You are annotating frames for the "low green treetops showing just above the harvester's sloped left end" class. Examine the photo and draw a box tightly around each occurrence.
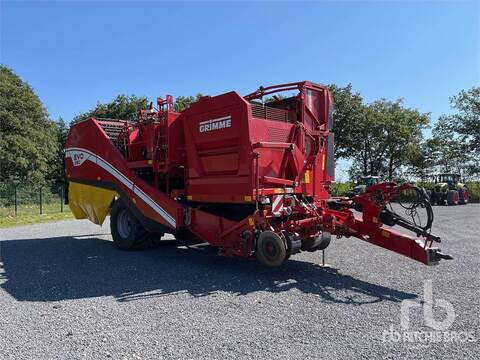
[72,95,148,123]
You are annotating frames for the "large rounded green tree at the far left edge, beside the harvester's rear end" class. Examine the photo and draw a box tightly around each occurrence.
[0,66,57,184]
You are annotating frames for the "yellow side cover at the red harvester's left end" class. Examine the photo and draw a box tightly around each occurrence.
[68,182,117,225]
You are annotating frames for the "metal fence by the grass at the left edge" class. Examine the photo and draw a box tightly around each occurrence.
[0,182,65,217]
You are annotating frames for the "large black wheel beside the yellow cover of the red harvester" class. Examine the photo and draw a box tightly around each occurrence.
[110,200,161,250]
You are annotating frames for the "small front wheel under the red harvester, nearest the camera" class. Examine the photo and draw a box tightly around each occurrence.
[255,231,287,267]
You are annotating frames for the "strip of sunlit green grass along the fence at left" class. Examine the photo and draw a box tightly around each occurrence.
[0,203,73,228]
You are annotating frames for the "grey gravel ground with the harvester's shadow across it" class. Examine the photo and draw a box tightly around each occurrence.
[0,204,480,359]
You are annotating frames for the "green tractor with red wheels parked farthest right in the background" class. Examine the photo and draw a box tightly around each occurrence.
[428,174,469,205]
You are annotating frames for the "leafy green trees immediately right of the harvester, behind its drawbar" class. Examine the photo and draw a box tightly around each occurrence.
[330,85,429,180]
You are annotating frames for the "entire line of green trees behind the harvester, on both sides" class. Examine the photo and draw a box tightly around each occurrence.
[0,66,480,186]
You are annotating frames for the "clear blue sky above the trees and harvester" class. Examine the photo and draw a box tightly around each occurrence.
[0,1,480,129]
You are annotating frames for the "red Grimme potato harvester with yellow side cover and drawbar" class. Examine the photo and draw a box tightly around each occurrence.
[66,81,451,266]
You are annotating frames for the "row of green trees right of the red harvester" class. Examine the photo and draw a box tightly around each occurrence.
[330,85,480,180]
